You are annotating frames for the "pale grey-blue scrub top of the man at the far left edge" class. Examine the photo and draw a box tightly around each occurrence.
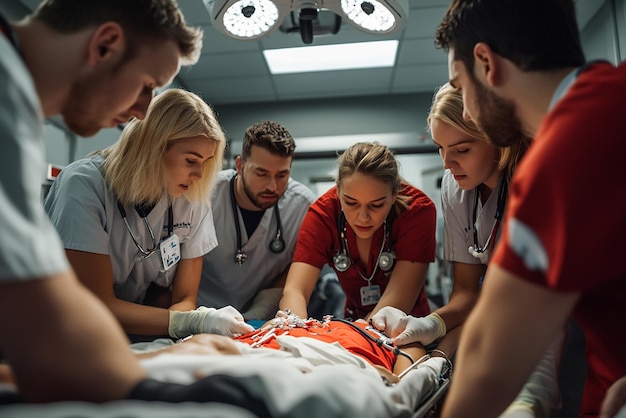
[0,33,69,282]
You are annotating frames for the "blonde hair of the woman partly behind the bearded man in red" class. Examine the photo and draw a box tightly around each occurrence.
[426,83,530,179]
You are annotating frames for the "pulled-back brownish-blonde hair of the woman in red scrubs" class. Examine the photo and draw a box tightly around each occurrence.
[336,142,409,215]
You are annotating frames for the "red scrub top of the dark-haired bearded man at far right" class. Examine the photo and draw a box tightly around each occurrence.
[491,60,626,417]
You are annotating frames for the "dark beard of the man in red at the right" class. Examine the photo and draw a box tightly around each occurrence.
[474,80,528,147]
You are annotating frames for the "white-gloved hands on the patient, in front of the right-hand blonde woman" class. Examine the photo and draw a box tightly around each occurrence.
[372,306,446,346]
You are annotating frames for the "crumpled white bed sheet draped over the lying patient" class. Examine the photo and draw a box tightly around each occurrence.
[133,335,445,418]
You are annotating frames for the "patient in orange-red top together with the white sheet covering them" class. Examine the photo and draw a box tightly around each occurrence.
[0,314,447,417]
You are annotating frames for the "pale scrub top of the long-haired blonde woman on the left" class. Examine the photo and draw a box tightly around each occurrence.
[44,156,217,303]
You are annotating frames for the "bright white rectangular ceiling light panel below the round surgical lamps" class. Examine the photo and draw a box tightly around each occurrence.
[263,40,398,74]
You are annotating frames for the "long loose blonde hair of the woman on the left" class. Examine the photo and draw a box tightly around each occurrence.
[96,89,226,205]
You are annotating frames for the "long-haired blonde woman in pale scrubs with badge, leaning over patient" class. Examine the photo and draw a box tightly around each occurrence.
[45,89,251,338]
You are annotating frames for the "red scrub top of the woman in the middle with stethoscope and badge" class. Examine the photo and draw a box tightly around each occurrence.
[293,184,436,320]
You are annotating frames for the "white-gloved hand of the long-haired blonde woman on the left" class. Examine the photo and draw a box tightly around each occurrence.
[168,305,254,338]
